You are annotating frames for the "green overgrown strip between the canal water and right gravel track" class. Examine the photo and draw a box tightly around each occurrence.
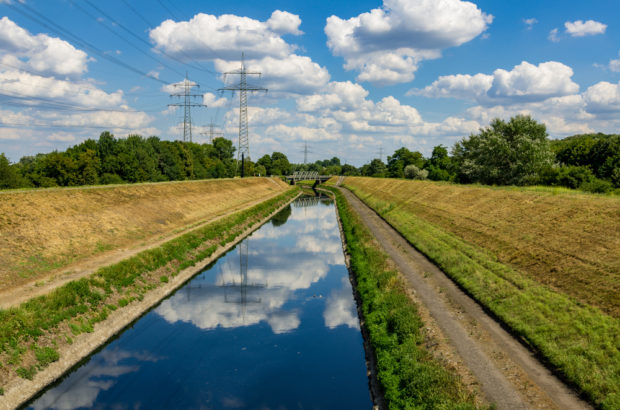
[329,188,476,409]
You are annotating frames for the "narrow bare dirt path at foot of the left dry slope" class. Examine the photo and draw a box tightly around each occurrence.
[0,191,281,309]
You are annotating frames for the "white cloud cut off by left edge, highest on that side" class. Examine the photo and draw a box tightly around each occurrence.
[0,17,88,76]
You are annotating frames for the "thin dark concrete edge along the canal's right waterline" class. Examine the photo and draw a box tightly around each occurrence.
[317,188,387,410]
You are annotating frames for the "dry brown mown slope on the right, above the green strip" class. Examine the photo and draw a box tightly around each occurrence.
[345,177,620,318]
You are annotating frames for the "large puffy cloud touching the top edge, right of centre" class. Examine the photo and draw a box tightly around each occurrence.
[325,0,493,84]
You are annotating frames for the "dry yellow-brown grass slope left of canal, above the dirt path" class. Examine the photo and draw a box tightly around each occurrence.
[0,178,288,290]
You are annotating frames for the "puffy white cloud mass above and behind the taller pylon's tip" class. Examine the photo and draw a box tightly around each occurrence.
[150,10,329,94]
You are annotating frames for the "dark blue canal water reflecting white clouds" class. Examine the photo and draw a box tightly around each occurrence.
[29,199,372,409]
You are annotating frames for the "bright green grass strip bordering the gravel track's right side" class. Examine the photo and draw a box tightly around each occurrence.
[347,180,620,409]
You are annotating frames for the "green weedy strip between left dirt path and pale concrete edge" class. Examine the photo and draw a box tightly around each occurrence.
[0,189,298,392]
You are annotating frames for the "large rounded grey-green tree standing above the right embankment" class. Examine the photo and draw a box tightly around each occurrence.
[453,115,554,185]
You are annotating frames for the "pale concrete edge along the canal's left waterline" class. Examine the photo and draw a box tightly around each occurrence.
[0,192,303,409]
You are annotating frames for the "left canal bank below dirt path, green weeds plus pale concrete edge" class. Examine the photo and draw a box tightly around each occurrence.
[0,189,300,409]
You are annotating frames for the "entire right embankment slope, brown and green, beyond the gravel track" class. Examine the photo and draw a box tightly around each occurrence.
[345,178,620,409]
